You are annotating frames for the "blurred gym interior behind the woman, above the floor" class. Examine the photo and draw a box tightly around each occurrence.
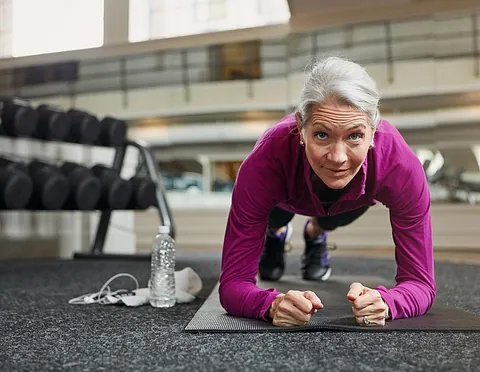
[0,0,480,260]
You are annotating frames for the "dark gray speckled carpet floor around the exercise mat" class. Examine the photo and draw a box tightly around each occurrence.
[0,253,480,371]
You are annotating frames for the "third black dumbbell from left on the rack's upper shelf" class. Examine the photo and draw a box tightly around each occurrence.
[65,109,101,145]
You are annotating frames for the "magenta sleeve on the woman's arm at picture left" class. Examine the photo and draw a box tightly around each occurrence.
[219,142,281,320]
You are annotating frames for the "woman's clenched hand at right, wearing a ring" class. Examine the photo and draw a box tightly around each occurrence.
[347,283,388,327]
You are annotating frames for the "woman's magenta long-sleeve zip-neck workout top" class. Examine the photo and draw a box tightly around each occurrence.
[219,115,436,320]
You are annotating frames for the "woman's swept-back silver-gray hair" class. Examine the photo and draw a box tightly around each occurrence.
[297,57,380,129]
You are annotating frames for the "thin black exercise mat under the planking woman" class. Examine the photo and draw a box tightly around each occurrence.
[185,276,480,333]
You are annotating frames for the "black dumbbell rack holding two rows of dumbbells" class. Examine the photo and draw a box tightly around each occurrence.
[0,96,175,259]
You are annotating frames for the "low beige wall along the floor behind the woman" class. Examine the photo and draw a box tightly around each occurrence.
[135,192,480,253]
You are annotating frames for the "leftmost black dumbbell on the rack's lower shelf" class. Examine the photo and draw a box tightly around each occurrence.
[0,158,33,210]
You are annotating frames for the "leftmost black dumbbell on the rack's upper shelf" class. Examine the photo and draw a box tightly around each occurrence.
[0,98,38,137]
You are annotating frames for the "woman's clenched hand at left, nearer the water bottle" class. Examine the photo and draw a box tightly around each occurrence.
[268,290,323,327]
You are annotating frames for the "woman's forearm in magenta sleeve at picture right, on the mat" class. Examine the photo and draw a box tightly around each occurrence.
[376,280,436,319]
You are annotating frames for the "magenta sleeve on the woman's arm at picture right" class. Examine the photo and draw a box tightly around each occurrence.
[376,160,436,319]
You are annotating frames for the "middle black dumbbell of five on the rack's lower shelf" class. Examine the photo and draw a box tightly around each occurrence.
[60,162,102,211]
